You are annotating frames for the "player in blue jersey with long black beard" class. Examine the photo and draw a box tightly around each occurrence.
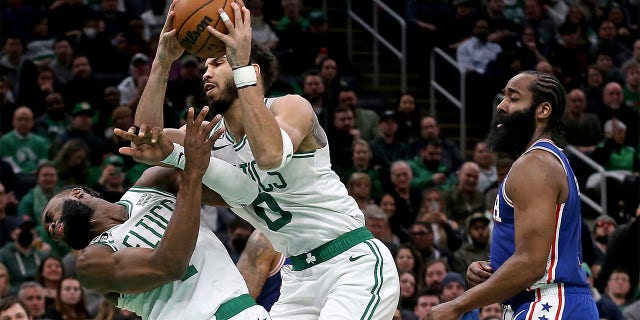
[427,71,598,320]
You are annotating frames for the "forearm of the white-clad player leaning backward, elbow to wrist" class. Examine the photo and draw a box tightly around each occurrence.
[154,170,202,279]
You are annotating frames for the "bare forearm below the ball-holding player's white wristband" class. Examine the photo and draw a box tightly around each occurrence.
[238,85,282,170]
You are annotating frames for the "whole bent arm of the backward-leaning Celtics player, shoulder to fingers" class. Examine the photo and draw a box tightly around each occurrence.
[76,109,214,293]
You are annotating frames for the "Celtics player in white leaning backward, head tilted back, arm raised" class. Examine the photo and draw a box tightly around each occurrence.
[43,108,269,320]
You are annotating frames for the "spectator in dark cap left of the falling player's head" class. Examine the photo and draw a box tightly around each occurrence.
[0,216,47,294]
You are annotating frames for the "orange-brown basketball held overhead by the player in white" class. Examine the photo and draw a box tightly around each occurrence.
[173,0,234,58]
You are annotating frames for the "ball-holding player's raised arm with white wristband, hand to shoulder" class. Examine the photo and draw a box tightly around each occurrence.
[205,3,314,170]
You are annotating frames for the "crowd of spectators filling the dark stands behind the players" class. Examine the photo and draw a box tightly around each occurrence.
[0,0,640,320]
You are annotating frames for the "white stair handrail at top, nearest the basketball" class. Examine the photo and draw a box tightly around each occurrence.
[347,0,407,92]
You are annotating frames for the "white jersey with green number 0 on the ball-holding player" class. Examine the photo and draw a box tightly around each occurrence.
[213,99,364,256]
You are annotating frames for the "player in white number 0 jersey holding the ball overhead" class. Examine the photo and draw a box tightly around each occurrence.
[135,3,400,320]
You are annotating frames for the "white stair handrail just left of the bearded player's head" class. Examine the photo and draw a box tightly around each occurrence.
[429,47,467,156]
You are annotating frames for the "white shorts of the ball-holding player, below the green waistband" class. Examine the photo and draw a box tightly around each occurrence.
[270,239,400,320]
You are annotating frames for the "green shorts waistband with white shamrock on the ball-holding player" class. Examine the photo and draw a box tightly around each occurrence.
[290,227,373,271]
